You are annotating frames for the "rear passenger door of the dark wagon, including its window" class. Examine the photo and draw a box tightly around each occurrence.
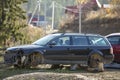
[70,36,89,61]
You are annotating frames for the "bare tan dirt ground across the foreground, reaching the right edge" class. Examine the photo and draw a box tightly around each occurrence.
[3,68,120,80]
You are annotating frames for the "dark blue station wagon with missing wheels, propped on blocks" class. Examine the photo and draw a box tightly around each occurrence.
[4,33,113,71]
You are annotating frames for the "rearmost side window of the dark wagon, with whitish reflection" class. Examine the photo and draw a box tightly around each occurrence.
[88,36,109,46]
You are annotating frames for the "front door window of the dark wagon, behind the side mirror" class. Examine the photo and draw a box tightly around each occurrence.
[52,36,70,46]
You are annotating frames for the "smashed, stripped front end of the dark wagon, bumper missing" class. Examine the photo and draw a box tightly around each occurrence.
[4,49,27,67]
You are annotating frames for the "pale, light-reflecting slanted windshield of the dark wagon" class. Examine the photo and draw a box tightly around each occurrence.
[32,34,60,46]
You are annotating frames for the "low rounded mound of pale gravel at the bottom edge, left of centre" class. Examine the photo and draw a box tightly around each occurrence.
[3,72,89,80]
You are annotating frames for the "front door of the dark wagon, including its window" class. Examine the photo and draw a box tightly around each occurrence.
[45,36,70,61]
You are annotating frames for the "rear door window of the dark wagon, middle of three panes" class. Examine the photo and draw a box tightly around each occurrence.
[73,36,88,45]
